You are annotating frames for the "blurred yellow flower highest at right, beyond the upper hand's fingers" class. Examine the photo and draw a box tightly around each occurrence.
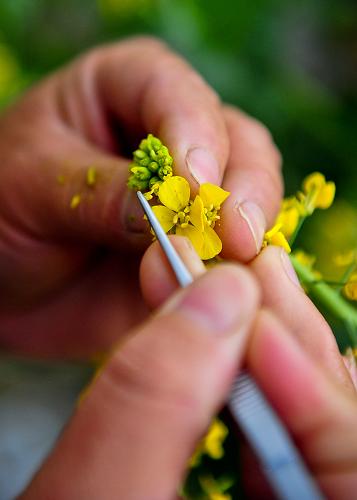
[300,172,336,215]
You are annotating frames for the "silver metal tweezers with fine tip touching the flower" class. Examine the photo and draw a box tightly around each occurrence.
[137,191,324,500]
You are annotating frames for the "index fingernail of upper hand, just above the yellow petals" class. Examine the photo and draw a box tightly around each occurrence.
[186,147,220,184]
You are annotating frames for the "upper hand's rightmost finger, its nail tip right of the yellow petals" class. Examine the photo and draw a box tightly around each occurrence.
[217,108,283,262]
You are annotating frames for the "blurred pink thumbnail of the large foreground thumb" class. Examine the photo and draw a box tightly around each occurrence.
[162,265,256,335]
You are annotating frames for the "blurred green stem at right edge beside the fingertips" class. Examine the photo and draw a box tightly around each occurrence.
[290,254,357,330]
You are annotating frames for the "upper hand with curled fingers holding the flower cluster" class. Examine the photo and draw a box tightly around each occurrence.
[0,38,282,357]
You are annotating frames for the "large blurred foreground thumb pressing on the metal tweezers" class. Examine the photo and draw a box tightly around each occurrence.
[22,265,258,500]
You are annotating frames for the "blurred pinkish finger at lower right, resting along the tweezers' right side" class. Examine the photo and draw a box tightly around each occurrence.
[248,312,357,499]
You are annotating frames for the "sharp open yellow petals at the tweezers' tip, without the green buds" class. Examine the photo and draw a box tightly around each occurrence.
[153,176,229,260]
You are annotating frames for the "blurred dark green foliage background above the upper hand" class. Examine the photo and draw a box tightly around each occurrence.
[0,0,357,270]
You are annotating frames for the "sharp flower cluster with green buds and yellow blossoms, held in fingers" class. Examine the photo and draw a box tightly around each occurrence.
[128,134,229,260]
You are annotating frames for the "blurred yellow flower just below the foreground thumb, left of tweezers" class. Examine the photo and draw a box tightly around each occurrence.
[190,418,228,467]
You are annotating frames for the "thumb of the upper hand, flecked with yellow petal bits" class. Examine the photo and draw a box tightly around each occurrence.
[1,106,150,245]
